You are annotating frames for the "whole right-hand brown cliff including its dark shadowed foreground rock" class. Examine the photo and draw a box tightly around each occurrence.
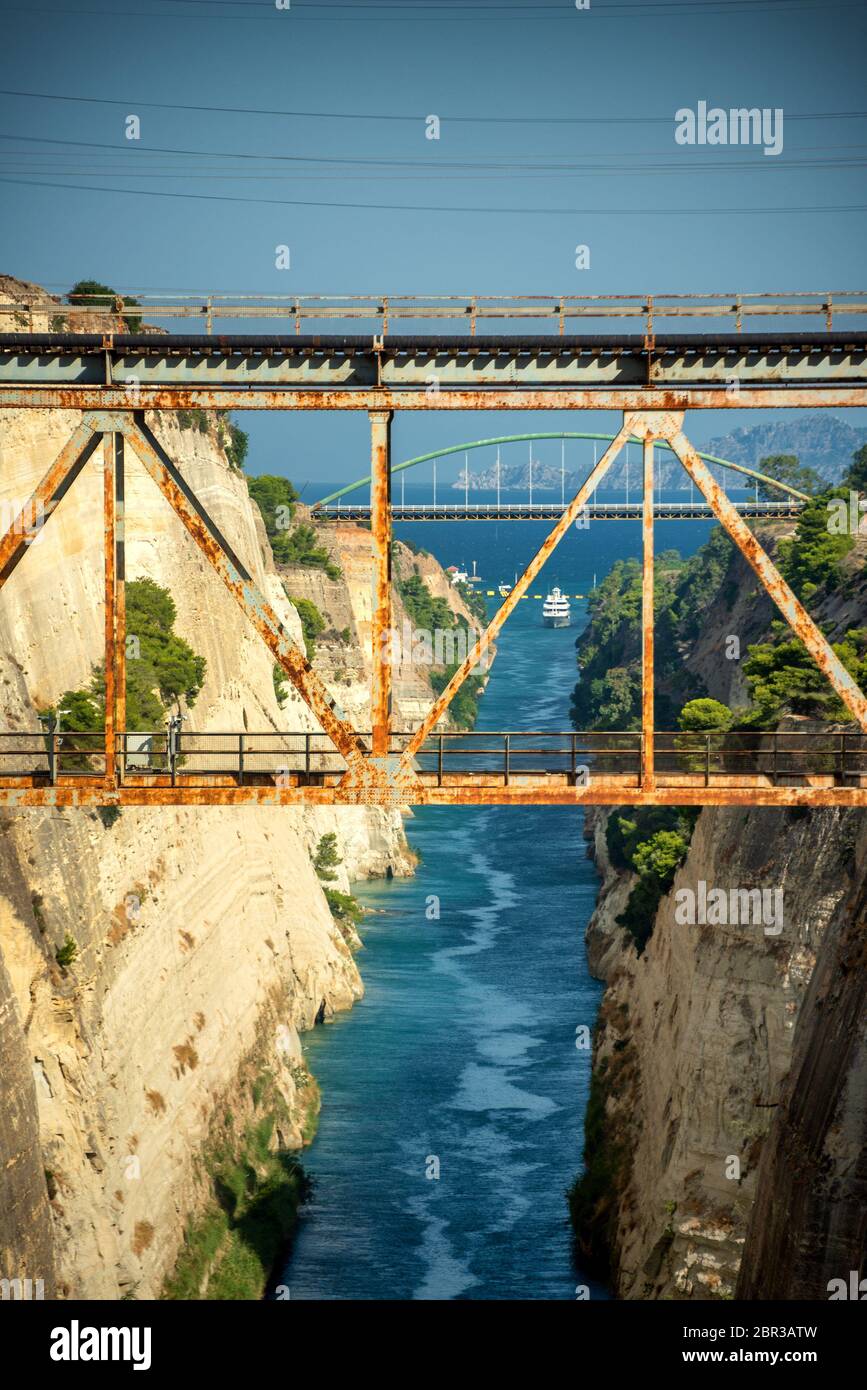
[582,517,867,1298]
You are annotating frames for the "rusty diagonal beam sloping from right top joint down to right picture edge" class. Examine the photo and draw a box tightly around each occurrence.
[671,430,867,733]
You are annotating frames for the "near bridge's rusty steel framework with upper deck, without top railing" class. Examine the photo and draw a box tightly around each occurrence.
[0,303,867,808]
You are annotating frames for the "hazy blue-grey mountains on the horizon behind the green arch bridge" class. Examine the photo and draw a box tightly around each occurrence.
[452,410,867,498]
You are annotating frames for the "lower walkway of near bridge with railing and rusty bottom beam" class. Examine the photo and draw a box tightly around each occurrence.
[0,728,867,808]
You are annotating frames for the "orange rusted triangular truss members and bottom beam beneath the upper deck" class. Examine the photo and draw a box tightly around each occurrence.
[0,388,867,808]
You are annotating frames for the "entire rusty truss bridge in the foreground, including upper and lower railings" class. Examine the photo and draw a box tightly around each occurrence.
[0,292,867,809]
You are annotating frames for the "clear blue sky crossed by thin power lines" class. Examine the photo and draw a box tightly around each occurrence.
[0,0,867,489]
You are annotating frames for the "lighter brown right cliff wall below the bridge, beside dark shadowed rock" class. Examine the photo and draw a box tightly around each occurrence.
[588,808,867,1298]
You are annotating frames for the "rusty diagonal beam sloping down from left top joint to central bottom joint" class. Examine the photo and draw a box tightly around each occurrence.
[122,410,363,766]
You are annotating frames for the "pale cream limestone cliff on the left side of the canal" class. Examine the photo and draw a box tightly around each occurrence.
[0,281,469,1298]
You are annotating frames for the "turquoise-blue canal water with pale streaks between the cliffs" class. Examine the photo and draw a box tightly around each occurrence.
[282,498,709,1298]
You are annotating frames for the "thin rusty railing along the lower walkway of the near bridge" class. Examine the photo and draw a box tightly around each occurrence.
[0,726,867,799]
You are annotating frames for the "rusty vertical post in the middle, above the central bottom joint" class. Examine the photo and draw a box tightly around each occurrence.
[370,410,393,758]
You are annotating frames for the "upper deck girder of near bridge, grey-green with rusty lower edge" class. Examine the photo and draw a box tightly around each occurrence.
[0,327,867,410]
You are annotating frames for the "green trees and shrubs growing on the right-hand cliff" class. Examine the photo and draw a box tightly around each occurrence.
[568,446,867,1275]
